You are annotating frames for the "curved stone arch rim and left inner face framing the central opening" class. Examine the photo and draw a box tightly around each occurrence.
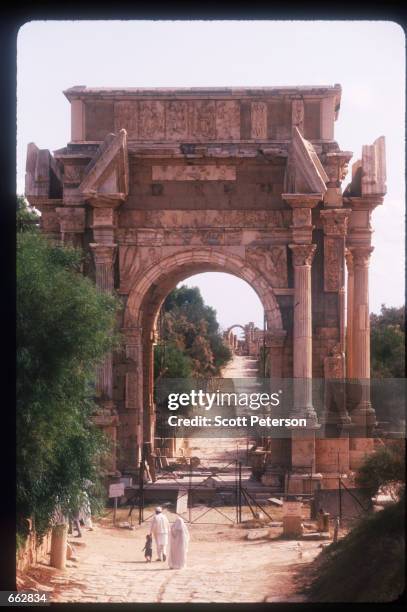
[121,249,285,474]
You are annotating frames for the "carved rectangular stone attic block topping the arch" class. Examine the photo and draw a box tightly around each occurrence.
[64,85,341,143]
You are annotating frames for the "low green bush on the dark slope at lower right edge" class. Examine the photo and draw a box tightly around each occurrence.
[356,440,405,496]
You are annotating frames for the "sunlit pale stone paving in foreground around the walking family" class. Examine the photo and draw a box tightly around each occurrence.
[35,516,320,603]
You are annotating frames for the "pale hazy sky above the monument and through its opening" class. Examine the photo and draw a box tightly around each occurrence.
[17,21,405,327]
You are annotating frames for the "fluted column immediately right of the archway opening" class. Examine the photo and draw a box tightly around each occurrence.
[289,244,316,421]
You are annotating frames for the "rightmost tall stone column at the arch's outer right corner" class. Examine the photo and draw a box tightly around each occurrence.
[349,246,375,425]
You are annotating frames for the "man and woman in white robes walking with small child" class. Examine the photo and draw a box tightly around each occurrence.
[143,506,189,569]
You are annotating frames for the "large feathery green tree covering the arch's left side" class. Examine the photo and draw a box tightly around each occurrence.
[16,232,119,534]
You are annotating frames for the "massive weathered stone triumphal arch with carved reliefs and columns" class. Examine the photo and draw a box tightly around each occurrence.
[26,85,386,488]
